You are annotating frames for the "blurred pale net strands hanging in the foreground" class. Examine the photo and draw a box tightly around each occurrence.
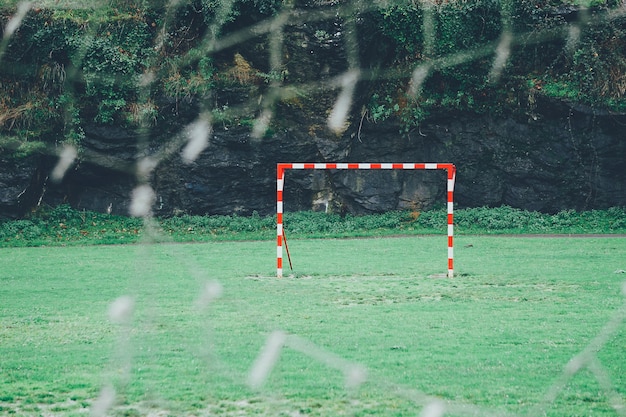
[0,0,626,417]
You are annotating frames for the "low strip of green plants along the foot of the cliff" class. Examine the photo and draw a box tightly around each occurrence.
[0,205,626,247]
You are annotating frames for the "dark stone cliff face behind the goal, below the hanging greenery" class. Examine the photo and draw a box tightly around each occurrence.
[0,94,626,217]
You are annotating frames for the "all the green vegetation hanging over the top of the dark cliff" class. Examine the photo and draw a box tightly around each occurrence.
[0,0,626,157]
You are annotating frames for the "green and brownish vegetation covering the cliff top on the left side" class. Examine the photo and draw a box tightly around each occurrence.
[0,0,281,157]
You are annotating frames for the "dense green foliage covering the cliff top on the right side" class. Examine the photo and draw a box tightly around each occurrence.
[368,0,626,127]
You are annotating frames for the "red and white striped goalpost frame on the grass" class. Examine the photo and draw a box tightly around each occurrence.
[276,163,456,278]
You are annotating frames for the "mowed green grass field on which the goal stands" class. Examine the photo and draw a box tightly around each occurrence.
[0,235,626,416]
